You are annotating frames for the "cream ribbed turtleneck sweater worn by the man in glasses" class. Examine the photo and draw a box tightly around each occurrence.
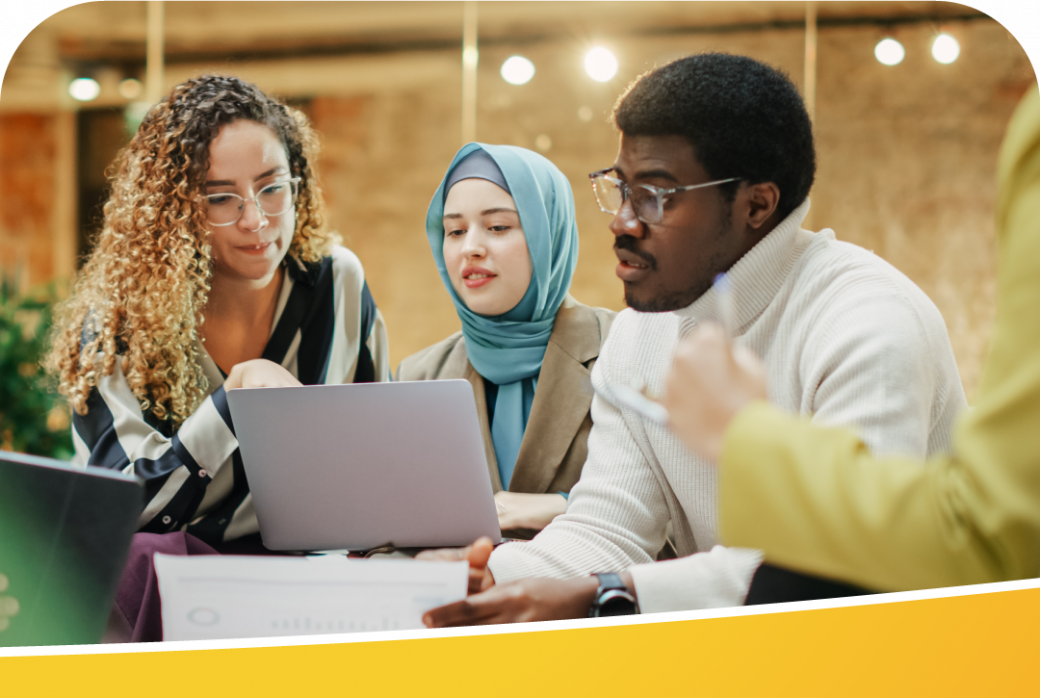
[490,201,965,613]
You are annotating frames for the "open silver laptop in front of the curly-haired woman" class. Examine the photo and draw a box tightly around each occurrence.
[228,380,501,550]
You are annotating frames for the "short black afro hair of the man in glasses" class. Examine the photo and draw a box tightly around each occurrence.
[614,53,816,218]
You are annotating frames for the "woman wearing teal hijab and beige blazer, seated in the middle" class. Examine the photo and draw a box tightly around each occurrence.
[397,144,615,536]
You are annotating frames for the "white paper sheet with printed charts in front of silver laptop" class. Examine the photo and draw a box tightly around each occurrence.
[155,554,468,640]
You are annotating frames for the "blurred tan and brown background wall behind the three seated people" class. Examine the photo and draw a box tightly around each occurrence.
[0,0,1037,394]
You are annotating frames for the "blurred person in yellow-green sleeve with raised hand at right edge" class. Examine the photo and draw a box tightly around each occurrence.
[665,86,1040,591]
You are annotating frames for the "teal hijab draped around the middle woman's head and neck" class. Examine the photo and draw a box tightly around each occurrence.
[426,143,578,489]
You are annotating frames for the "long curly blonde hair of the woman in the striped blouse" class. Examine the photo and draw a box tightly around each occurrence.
[45,75,339,431]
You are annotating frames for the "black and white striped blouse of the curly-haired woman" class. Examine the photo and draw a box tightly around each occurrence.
[73,247,390,543]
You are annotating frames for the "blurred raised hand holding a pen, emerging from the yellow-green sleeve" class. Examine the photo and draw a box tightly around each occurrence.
[661,324,766,462]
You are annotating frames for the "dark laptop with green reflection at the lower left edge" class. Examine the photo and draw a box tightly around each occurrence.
[0,451,145,647]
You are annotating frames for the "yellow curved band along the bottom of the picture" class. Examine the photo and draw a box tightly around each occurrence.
[0,579,1040,698]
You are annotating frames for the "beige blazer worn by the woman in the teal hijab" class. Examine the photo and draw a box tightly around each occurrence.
[396,295,617,494]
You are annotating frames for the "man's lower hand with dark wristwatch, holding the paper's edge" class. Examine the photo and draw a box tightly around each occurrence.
[422,576,599,627]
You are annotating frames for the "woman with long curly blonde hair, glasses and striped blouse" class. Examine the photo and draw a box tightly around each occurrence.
[48,76,389,640]
